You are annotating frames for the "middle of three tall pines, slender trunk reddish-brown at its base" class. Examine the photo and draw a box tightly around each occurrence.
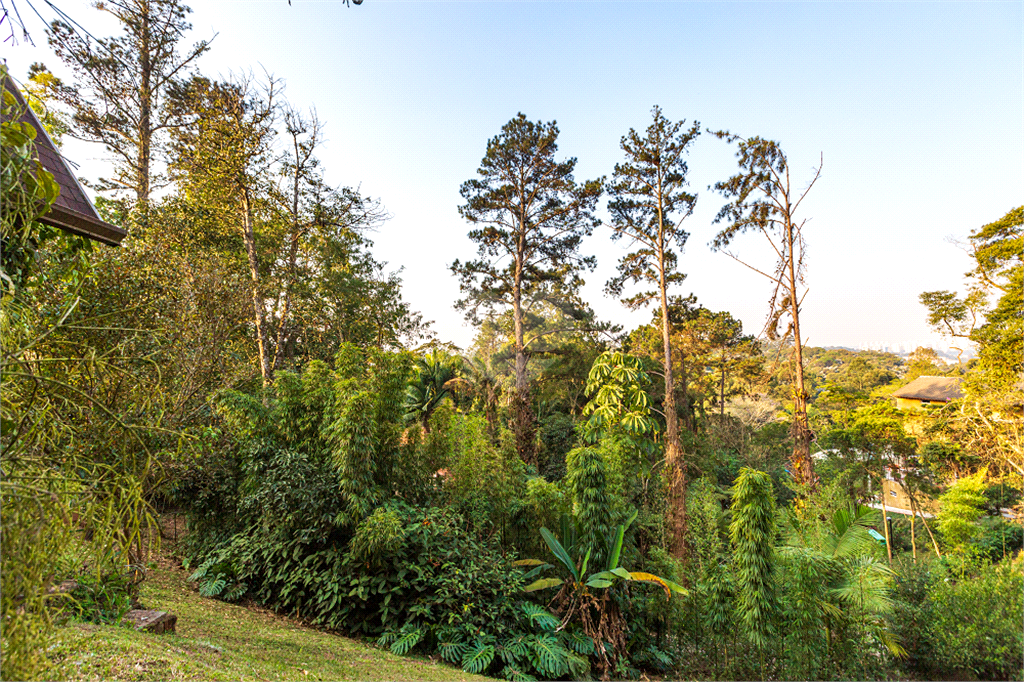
[606,106,700,556]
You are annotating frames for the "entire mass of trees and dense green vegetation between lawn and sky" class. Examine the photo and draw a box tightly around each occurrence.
[0,9,1024,681]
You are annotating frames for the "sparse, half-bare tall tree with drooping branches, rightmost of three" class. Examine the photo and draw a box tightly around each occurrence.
[711,132,821,489]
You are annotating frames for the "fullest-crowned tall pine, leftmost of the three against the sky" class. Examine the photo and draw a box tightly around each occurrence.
[452,114,603,463]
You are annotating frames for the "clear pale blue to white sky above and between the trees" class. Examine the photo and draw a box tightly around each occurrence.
[4,0,1024,356]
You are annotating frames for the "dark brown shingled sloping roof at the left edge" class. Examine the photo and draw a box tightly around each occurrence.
[3,77,128,246]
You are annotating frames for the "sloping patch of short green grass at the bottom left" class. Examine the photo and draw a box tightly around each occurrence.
[48,561,487,680]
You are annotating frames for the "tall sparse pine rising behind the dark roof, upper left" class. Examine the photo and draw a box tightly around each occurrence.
[47,0,210,206]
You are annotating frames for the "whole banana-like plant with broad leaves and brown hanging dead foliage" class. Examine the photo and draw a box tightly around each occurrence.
[516,512,686,671]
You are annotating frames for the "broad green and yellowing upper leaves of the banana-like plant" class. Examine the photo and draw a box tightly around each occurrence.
[515,512,686,597]
